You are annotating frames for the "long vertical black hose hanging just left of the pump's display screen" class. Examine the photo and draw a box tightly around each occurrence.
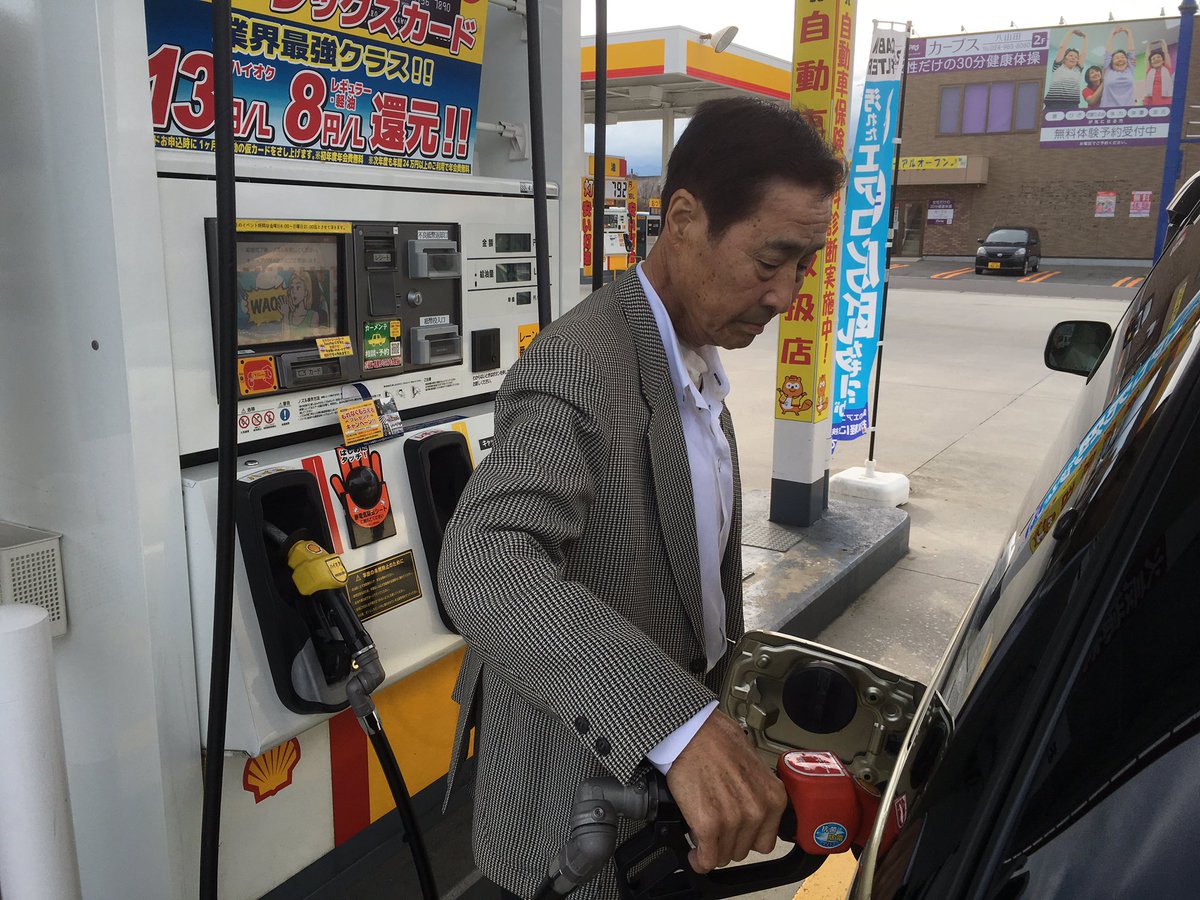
[199,0,238,900]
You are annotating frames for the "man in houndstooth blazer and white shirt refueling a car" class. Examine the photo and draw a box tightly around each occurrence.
[439,98,842,898]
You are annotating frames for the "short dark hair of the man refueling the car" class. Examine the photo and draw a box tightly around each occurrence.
[662,97,845,238]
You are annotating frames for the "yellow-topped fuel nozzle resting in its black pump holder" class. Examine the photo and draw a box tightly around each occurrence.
[263,523,384,734]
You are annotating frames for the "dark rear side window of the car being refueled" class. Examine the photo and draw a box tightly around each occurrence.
[989,376,1200,898]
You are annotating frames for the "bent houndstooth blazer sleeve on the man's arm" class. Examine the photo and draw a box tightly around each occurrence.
[438,335,715,780]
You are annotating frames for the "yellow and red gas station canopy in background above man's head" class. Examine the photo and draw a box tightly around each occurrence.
[581,25,791,125]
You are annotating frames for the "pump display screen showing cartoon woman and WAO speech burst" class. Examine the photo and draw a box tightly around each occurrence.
[238,234,342,347]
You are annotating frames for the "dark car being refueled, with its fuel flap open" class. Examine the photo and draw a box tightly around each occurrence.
[721,173,1200,900]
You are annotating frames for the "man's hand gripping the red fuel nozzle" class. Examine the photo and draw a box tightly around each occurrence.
[667,709,787,875]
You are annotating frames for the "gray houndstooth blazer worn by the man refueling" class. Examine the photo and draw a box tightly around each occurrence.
[439,272,744,900]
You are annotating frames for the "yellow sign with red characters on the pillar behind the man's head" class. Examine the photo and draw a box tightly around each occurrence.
[775,0,854,422]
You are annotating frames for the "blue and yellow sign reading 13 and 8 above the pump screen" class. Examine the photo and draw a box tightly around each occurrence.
[145,0,487,174]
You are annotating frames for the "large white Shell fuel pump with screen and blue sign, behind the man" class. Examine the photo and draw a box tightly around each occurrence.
[0,0,583,900]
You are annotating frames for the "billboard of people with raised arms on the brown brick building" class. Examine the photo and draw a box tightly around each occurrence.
[1042,19,1180,148]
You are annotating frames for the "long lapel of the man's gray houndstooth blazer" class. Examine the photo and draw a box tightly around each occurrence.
[617,271,704,647]
